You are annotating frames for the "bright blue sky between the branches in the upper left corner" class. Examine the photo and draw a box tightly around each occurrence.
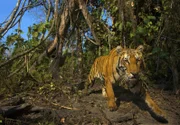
[0,0,42,39]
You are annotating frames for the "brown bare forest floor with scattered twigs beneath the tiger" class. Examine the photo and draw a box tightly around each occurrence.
[0,82,180,125]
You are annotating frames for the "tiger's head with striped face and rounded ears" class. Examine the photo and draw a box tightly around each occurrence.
[117,45,144,81]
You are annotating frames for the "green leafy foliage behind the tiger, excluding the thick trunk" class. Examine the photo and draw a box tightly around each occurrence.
[0,0,180,92]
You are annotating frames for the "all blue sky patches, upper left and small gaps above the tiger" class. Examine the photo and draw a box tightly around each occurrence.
[0,0,112,41]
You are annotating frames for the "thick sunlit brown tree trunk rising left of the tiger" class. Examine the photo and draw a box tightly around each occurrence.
[47,0,75,80]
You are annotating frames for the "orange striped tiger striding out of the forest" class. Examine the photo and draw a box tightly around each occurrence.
[85,45,167,122]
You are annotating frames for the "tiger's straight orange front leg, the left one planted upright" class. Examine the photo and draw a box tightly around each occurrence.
[105,79,117,111]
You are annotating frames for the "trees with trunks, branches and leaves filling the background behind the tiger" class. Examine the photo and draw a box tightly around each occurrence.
[0,0,180,92]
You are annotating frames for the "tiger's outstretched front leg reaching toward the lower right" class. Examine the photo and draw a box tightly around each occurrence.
[131,83,168,122]
